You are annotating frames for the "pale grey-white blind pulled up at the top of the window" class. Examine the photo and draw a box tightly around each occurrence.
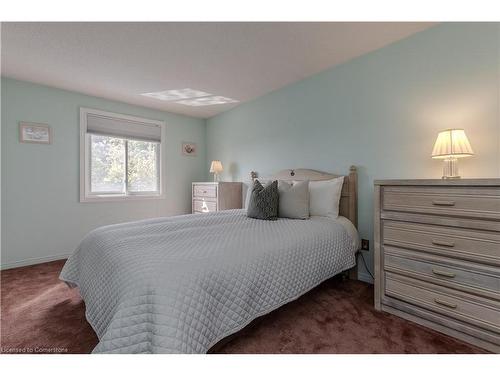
[86,113,161,142]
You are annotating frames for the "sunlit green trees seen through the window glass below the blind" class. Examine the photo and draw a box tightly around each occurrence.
[89,134,159,194]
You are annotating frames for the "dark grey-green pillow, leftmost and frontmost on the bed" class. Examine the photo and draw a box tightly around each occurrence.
[247,180,279,220]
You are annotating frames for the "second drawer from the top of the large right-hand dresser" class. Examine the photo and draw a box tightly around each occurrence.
[382,220,500,265]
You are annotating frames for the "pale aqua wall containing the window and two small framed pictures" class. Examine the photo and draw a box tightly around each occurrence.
[1,78,206,266]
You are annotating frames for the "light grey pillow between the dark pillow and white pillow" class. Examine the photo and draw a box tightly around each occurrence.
[278,180,309,219]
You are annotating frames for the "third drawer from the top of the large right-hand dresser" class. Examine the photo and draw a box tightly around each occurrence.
[384,247,500,300]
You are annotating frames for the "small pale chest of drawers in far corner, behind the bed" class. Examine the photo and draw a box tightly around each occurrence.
[192,182,242,214]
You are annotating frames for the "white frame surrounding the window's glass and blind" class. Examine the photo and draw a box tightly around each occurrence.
[80,107,165,202]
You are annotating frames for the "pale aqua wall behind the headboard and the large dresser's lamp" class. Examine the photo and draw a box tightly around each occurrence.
[207,24,500,278]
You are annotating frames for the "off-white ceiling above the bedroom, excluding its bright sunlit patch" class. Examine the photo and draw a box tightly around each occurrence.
[1,22,433,118]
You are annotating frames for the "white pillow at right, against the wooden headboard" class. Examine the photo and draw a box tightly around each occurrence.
[309,176,344,218]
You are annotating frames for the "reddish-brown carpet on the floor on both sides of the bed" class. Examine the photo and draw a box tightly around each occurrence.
[0,261,484,353]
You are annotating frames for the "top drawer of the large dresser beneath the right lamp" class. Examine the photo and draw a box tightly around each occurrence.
[382,186,500,220]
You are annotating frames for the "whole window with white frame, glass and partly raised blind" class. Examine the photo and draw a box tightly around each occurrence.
[80,108,163,202]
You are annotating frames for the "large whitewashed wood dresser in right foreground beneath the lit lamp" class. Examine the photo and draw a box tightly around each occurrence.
[374,179,500,352]
